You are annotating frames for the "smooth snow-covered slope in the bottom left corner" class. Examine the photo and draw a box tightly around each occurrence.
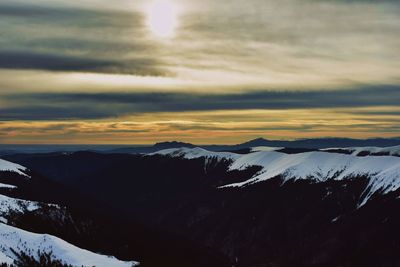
[0,223,138,267]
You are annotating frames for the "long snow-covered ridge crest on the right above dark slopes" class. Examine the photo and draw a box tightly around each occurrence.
[155,148,400,205]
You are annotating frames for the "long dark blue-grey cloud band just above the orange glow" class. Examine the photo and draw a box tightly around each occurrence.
[0,86,400,120]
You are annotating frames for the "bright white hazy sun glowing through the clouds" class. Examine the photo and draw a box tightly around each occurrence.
[147,0,178,38]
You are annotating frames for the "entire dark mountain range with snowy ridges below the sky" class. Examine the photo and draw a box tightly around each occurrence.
[0,139,400,267]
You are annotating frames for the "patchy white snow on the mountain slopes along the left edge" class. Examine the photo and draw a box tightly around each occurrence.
[0,159,139,267]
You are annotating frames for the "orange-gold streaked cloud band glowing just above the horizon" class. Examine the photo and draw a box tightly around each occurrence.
[0,107,400,144]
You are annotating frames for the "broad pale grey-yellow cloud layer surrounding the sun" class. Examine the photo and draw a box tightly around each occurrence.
[0,0,400,87]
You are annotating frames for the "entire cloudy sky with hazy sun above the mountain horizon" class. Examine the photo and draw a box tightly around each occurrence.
[0,0,400,144]
